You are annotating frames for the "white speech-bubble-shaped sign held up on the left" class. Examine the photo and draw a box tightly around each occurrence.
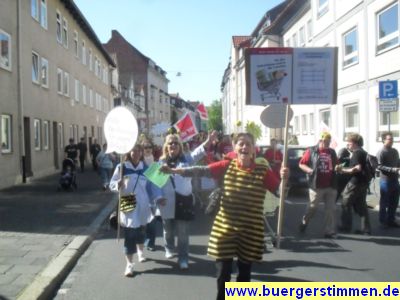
[104,106,138,154]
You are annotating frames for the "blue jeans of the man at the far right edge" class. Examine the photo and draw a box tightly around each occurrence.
[379,178,400,225]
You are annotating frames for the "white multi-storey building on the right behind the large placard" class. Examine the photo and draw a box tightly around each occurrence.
[223,0,400,153]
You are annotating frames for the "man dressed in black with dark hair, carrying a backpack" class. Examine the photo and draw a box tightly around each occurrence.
[336,133,371,235]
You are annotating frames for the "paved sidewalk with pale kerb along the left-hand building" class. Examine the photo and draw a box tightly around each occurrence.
[0,168,116,300]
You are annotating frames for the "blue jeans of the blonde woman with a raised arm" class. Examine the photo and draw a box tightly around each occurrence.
[163,219,190,262]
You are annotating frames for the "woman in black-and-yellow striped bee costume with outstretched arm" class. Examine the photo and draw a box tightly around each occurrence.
[163,133,288,299]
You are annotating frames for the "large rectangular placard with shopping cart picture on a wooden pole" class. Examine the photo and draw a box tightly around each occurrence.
[245,47,337,105]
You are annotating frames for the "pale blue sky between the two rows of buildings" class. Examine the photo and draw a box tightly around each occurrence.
[74,0,283,105]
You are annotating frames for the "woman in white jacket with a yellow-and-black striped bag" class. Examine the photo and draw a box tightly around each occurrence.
[110,144,165,277]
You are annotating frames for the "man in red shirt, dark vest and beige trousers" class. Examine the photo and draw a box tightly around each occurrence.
[299,132,337,238]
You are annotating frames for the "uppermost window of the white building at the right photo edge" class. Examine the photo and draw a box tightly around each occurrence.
[376,1,399,53]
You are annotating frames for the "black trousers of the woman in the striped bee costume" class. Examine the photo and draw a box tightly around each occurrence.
[216,258,251,300]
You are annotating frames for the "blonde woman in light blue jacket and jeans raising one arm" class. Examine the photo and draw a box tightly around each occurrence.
[158,133,216,269]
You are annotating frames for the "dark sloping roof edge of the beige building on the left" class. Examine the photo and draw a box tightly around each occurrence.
[60,0,116,68]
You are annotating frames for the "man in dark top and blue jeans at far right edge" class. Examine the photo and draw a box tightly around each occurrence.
[377,132,400,228]
